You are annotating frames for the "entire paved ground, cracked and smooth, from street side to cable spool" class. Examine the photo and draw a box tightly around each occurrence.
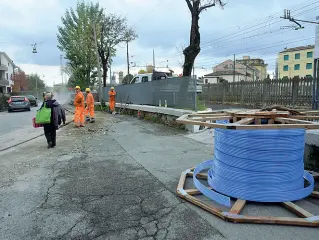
[0,113,318,240]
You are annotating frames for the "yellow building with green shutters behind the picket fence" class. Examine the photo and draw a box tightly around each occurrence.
[278,45,315,78]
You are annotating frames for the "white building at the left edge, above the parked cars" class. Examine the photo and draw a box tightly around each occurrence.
[0,52,16,93]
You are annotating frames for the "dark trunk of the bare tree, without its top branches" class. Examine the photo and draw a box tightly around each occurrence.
[183,12,200,76]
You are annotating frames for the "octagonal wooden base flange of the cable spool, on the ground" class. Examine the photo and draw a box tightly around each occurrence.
[177,168,319,227]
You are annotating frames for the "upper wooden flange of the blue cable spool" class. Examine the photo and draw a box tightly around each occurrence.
[176,108,319,130]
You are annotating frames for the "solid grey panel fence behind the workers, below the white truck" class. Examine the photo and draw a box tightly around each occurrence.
[103,77,196,110]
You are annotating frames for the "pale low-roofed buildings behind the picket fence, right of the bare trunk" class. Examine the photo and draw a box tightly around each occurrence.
[203,59,260,84]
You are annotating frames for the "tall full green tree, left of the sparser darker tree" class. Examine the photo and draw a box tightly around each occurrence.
[57,1,103,87]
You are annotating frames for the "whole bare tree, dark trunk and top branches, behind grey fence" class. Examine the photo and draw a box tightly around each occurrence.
[183,0,225,76]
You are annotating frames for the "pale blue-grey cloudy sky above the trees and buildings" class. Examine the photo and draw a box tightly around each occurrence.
[0,0,319,85]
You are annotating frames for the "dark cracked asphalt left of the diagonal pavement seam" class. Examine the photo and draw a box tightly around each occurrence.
[0,115,225,240]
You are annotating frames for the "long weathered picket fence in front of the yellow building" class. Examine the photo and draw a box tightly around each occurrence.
[200,78,314,107]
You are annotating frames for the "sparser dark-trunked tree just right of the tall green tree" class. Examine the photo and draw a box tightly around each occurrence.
[97,13,137,87]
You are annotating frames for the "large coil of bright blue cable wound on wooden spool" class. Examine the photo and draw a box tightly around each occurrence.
[193,121,314,207]
